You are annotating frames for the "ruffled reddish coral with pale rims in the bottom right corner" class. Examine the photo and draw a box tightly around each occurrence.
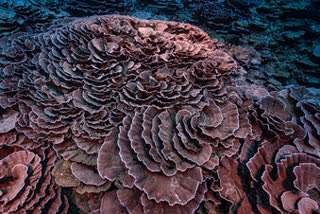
[247,142,320,213]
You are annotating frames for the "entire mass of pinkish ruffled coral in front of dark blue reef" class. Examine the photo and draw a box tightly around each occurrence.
[0,7,320,214]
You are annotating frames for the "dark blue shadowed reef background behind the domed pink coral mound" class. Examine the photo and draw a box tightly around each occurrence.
[0,0,320,88]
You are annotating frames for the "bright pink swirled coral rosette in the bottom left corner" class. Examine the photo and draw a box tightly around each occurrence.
[0,148,69,213]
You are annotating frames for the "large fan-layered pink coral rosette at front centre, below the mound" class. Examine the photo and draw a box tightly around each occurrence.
[98,93,250,213]
